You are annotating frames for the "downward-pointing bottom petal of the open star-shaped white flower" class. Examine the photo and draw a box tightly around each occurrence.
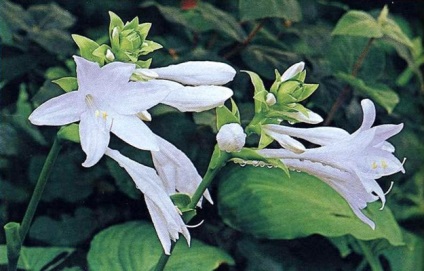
[79,111,110,167]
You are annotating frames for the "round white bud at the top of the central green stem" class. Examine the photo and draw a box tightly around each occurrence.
[216,123,246,152]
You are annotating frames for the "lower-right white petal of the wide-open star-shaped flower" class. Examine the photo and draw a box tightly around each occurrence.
[111,115,159,151]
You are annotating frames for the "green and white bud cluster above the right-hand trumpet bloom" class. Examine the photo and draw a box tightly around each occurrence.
[246,62,322,147]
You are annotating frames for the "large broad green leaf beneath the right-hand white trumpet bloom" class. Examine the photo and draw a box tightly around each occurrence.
[218,167,403,245]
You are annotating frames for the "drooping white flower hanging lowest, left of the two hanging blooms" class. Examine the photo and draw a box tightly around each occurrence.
[106,148,190,254]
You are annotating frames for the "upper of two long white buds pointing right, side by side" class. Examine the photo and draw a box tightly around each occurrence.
[151,61,236,85]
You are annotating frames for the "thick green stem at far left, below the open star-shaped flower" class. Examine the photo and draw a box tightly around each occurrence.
[4,138,61,271]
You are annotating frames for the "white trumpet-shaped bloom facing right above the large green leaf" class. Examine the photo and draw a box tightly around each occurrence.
[259,99,404,228]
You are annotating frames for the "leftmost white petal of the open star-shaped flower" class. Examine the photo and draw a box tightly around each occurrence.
[29,91,86,126]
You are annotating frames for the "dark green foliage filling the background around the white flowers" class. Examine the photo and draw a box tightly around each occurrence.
[0,0,424,271]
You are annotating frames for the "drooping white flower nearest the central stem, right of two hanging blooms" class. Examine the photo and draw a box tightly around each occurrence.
[151,136,213,207]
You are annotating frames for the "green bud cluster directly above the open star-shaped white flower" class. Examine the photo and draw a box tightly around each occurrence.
[72,12,162,68]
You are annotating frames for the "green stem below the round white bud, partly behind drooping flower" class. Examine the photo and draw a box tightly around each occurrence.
[154,146,230,271]
